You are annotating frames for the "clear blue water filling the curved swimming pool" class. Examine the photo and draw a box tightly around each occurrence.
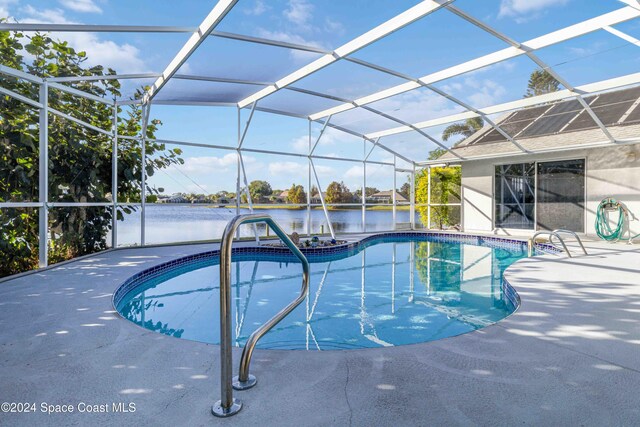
[117,236,526,350]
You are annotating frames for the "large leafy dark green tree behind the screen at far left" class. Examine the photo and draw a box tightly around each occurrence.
[0,28,183,276]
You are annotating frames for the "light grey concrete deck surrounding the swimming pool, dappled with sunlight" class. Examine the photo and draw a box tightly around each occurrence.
[0,236,640,426]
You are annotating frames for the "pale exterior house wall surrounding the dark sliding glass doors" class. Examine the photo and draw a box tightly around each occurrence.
[462,144,640,236]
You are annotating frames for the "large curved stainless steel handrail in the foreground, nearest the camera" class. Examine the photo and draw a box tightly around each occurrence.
[211,214,310,417]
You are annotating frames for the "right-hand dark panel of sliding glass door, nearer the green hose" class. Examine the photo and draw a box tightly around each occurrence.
[536,159,585,233]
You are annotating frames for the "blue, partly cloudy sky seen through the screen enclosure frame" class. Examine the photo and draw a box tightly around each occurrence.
[0,0,640,194]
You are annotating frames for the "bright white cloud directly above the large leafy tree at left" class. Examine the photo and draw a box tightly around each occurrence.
[19,5,148,74]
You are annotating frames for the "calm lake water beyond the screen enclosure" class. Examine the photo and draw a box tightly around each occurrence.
[118,204,409,245]
